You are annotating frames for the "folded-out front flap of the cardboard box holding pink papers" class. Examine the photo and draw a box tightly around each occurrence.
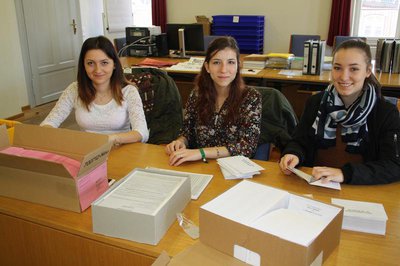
[0,153,72,178]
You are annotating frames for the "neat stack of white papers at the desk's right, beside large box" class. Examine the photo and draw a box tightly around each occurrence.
[332,198,388,235]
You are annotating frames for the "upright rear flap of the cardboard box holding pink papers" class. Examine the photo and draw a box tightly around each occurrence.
[13,124,108,160]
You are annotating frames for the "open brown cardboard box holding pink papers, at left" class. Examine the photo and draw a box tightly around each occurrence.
[0,124,111,212]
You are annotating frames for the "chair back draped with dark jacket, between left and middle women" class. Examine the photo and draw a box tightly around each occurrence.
[125,67,183,144]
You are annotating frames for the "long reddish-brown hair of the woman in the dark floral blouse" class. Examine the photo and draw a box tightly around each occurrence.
[195,37,246,125]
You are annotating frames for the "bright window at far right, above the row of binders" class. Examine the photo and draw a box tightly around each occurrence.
[351,0,400,53]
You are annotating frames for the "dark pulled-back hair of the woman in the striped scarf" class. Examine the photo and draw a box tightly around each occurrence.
[332,39,382,98]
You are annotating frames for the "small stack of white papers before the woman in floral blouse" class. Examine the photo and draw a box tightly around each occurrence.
[217,155,264,179]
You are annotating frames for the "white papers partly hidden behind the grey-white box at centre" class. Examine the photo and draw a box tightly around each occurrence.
[146,167,213,200]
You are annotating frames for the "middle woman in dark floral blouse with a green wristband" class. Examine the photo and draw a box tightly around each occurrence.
[166,37,261,165]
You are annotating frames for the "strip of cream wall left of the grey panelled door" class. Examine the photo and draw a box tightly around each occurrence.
[0,0,28,118]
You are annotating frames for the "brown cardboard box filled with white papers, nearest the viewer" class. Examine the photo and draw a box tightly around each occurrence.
[199,181,343,265]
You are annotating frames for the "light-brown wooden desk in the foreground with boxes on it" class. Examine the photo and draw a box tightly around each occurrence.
[0,143,400,266]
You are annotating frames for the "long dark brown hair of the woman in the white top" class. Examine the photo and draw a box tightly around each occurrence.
[77,36,129,111]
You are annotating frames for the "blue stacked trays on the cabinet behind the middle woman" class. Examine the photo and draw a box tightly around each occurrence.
[212,15,264,54]
